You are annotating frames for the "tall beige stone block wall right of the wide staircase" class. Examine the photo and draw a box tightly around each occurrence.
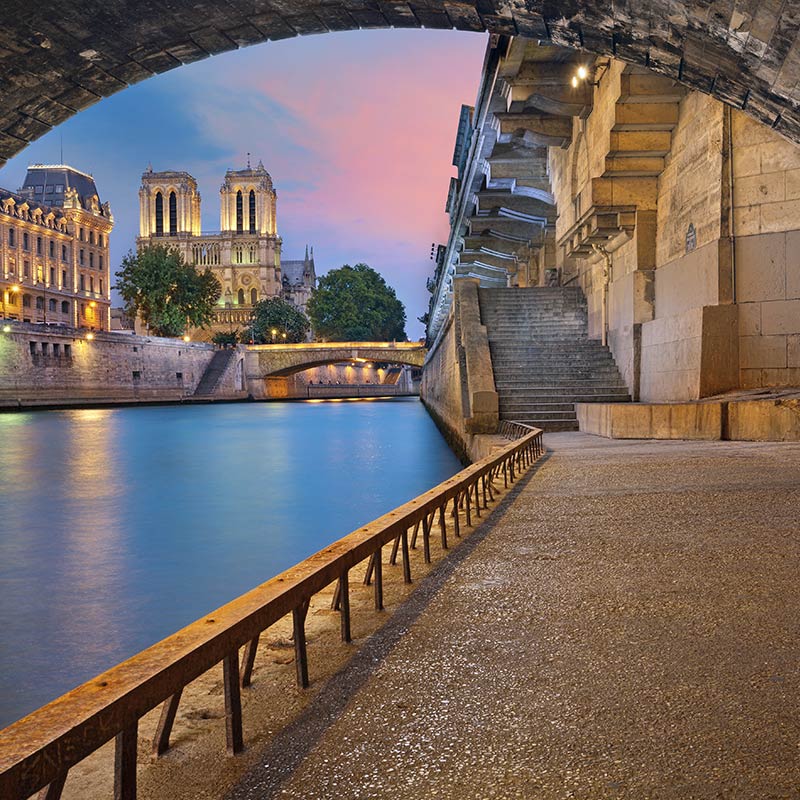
[549,57,800,401]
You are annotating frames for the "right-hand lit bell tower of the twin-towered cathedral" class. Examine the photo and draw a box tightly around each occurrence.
[219,161,278,236]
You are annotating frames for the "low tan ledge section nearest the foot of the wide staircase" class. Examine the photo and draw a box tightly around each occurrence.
[575,403,723,440]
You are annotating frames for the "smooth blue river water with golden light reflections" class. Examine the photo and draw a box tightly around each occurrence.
[0,398,461,728]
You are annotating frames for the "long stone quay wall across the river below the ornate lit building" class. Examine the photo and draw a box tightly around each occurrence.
[0,323,247,409]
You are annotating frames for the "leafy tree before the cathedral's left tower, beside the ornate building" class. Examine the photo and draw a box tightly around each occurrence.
[114,245,222,336]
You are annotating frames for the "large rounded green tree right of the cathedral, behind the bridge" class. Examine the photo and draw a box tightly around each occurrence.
[308,264,406,342]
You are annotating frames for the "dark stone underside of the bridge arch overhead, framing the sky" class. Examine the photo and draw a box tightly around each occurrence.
[0,0,800,166]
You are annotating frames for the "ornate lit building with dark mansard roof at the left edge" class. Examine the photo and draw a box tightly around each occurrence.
[0,164,114,330]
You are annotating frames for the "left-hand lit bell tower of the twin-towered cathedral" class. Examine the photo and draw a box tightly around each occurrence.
[139,167,200,237]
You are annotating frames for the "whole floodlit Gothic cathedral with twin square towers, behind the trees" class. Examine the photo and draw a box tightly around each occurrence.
[136,162,316,338]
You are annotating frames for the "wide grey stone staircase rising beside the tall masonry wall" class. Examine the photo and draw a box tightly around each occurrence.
[478,287,630,431]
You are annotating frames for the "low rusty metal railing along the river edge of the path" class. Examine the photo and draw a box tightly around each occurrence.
[0,423,544,800]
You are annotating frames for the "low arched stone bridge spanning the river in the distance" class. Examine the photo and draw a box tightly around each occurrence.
[245,342,428,398]
